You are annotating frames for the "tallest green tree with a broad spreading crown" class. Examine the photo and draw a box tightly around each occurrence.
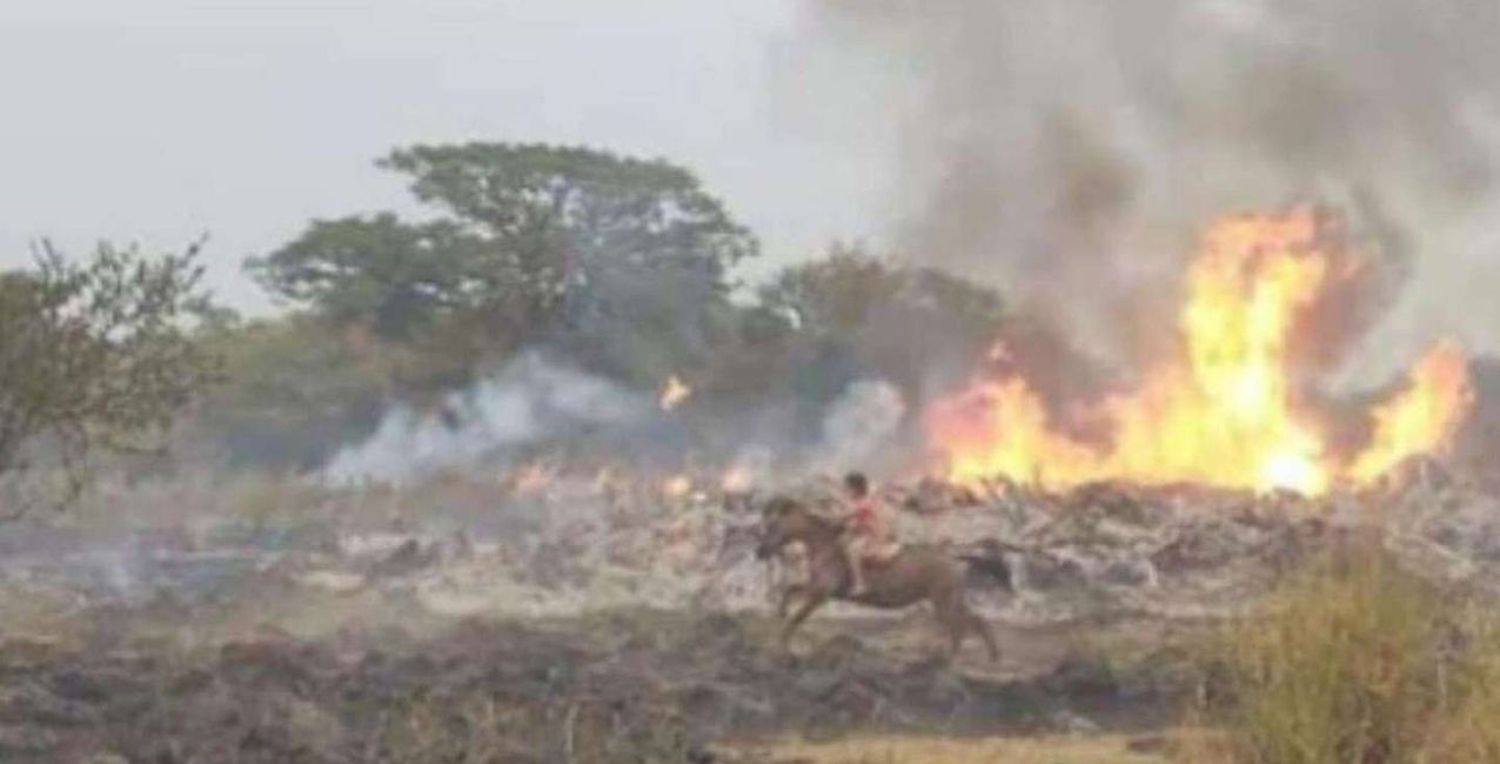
[249,143,756,384]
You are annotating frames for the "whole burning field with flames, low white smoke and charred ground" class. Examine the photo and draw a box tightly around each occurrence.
[0,198,1500,764]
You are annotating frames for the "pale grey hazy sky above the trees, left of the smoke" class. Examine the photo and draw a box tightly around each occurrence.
[0,0,878,309]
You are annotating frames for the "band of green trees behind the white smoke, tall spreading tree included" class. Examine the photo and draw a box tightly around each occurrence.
[213,143,1004,465]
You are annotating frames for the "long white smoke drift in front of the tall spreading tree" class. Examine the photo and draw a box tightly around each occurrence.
[323,351,656,483]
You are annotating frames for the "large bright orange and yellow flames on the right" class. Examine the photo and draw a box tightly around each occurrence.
[927,209,1472,494]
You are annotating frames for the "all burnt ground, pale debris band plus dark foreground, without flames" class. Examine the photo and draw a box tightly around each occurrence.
[0,461,1500,762]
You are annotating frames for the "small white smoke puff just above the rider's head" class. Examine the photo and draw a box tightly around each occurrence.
[815,380,906,471]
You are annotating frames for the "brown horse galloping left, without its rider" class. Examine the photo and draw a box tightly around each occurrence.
[756,497,1010,660]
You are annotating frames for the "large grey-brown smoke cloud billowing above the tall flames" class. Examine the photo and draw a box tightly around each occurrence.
[780,0,1500,378]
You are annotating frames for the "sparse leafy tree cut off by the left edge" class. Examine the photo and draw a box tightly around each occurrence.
[0,243,219,515]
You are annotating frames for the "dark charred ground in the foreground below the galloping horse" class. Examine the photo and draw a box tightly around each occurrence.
[0,611,1191,764]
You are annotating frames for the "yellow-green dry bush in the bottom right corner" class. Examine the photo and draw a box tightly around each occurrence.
[1209,545,1500,764]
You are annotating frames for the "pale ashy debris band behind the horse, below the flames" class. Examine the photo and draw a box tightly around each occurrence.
[0,461,1500,623]
